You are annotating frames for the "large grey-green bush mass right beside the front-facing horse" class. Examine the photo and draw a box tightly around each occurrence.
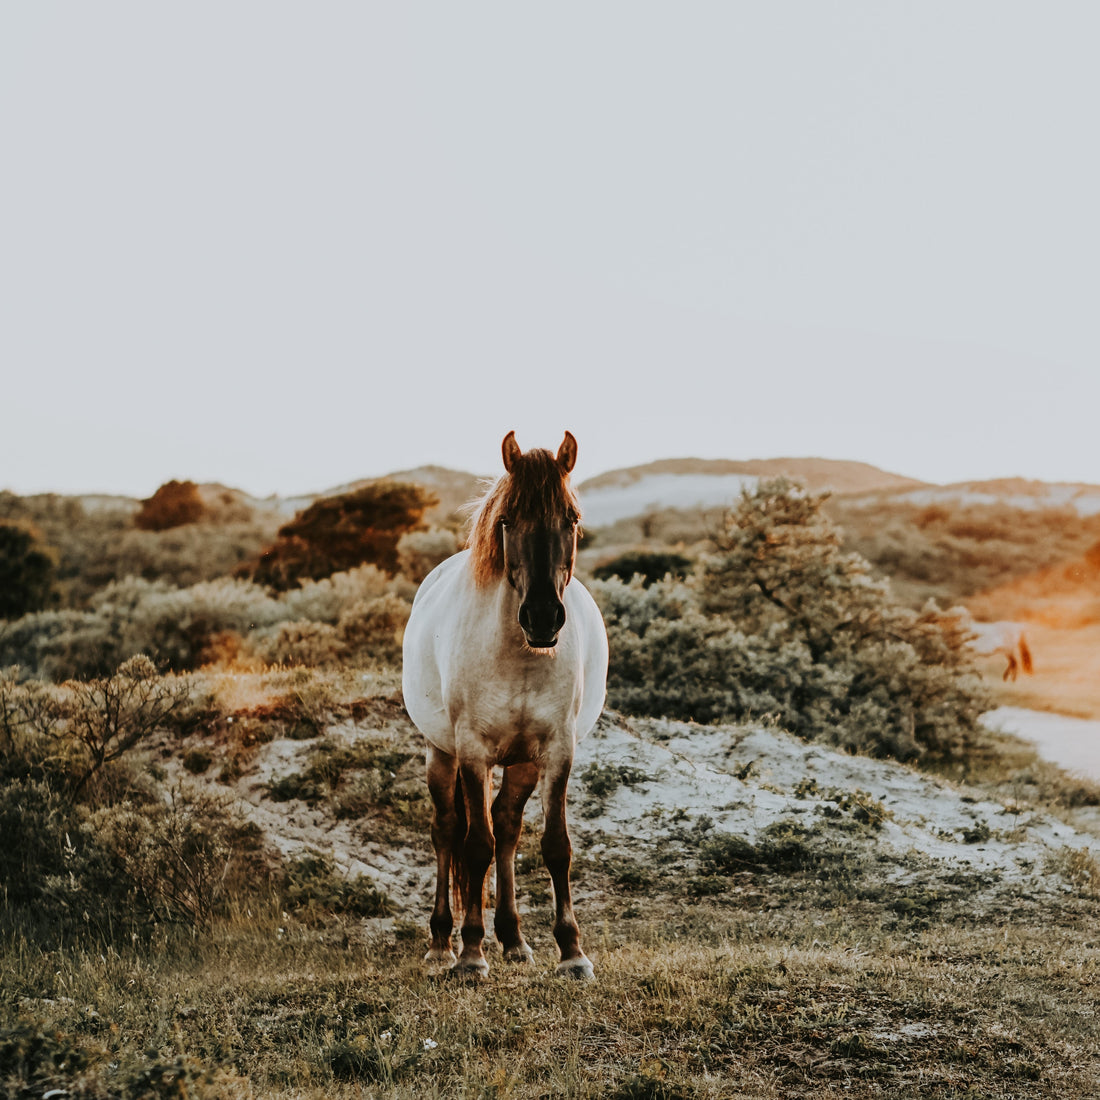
[593,482,988,760]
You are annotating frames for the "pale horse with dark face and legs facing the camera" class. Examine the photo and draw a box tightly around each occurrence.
[402,431,607,979]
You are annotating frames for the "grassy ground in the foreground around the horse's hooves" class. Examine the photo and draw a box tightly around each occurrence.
[0,840,1100,1100]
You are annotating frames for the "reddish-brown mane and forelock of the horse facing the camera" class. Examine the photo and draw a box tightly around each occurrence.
[466,448,581,585]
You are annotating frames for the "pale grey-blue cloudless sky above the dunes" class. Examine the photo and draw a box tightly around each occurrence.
[0,0,1100,496]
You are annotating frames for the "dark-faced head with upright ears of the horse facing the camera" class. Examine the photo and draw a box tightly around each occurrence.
[496,431,581,649]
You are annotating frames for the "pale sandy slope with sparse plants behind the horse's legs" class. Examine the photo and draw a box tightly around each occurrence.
[212,713,1097,913]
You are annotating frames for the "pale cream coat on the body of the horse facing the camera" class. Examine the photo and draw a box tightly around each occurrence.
[402,550,607,767]
